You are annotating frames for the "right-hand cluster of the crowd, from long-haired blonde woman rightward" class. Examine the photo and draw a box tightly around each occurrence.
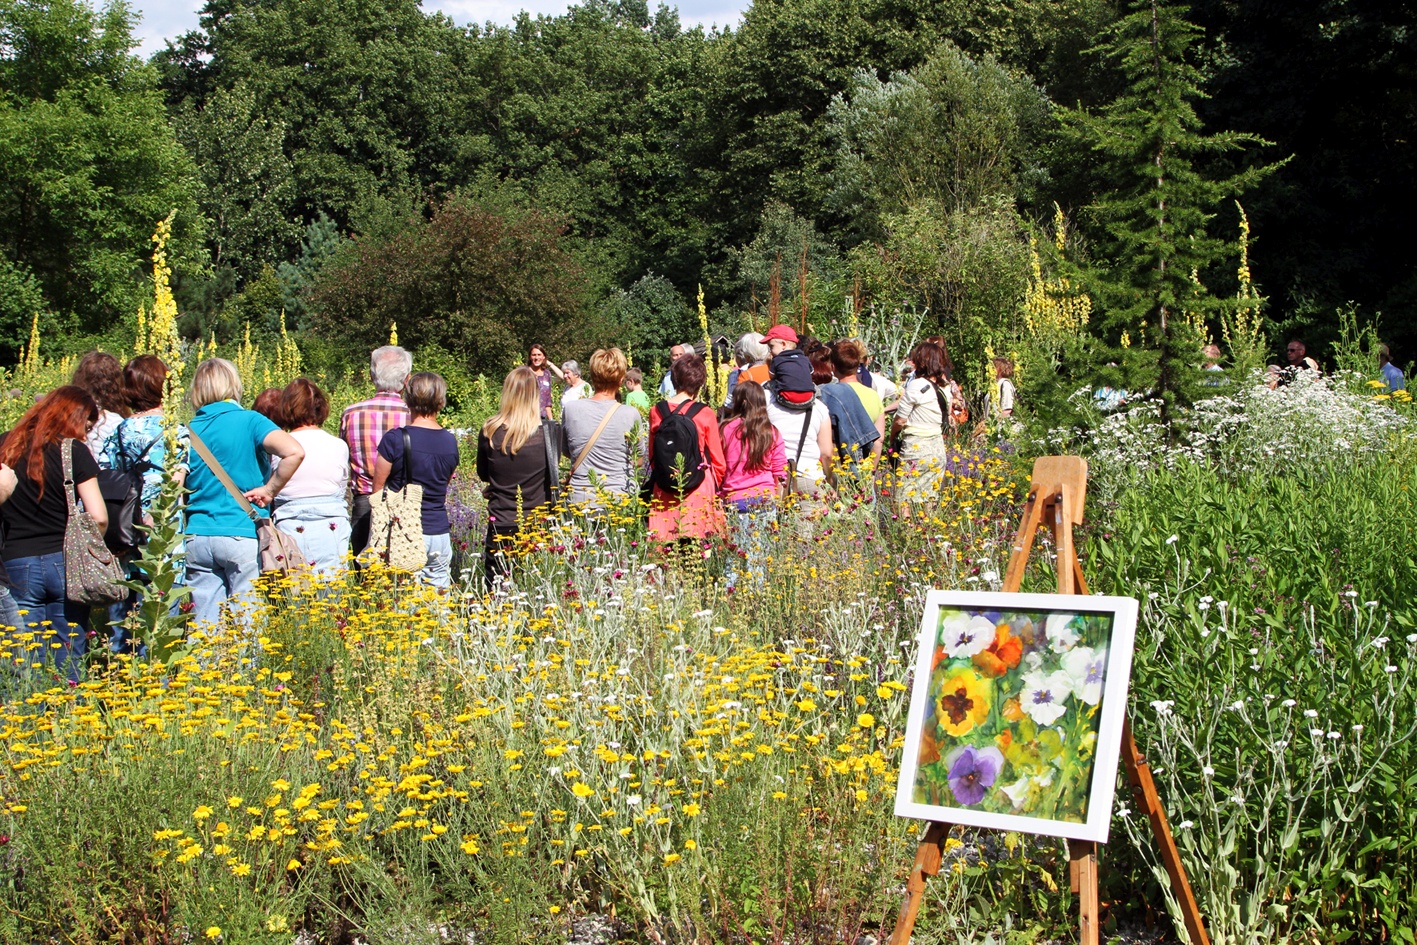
[478,324,997,587]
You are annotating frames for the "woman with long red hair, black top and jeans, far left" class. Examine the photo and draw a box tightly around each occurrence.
[0,385,108,681]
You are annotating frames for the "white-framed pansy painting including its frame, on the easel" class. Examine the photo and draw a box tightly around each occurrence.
[896,591,1136,843]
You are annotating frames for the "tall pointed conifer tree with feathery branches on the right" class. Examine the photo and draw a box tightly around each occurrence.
[1061,0,1278,428]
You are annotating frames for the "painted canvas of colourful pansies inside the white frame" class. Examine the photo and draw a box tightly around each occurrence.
[911,606,1114,823]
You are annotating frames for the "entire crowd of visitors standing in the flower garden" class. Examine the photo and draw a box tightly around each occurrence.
[16,324,1404,679]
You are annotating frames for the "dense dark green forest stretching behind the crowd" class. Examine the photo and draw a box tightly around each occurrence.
[0,0,1417,391]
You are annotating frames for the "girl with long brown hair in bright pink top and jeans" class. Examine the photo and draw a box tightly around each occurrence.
[718,380,788,591]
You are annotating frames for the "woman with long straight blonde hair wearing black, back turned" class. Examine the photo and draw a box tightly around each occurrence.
[478,367,558,582]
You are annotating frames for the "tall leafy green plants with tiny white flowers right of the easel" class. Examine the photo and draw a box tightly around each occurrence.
[1088,439,1417,942]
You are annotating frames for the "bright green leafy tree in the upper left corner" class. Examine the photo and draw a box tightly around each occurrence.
[0,0,201,346]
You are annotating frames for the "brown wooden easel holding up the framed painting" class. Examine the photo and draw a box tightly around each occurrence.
[890,456,1210,945]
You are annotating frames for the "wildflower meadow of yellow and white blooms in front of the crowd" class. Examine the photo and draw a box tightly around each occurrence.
[0,315,1417,944]
